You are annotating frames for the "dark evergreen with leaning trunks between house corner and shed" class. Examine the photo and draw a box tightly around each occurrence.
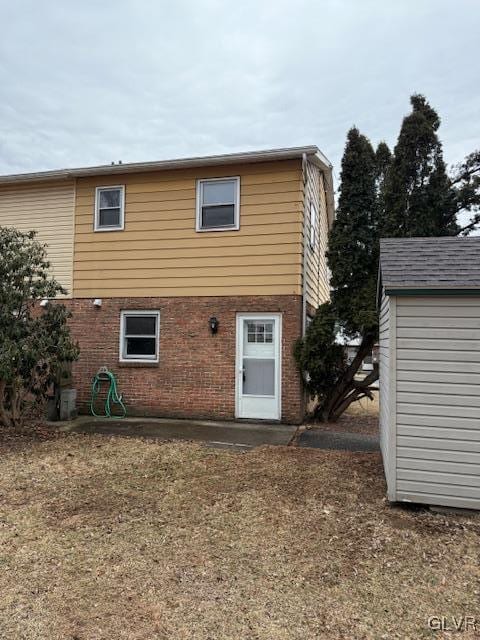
[295,127,380,420]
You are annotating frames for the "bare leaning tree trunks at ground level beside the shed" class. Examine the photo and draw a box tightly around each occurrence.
[314,334,378,422]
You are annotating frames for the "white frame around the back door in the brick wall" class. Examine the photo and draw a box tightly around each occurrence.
[235,311,282,421]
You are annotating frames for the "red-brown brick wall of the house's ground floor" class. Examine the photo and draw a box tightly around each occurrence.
[65,295,304,423]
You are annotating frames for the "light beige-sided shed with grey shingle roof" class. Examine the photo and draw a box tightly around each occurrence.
[378,237,480,509]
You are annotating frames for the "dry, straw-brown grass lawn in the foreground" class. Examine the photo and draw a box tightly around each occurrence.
[0,436,480,640]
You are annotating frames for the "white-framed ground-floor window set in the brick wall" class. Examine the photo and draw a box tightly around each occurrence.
[120,311,160,362]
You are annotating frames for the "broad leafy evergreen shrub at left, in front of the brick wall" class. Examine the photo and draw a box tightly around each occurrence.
[0,227,78,428]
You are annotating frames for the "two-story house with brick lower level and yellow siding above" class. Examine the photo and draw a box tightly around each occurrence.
[0,146,334,423]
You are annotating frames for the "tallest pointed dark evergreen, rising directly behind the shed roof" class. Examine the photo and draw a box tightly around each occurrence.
[381,95,459,237]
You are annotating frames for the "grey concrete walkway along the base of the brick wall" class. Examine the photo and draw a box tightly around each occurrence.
[58,416,297,451]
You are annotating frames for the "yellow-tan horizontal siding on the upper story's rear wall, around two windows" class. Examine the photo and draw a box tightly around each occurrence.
[74,160,303,297]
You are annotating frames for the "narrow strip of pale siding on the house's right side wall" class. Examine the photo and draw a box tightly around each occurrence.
[304,162,329,308]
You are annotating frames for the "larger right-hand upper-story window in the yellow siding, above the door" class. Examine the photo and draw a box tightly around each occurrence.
[197,178,240,231]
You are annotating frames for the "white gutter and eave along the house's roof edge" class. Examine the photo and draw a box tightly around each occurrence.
[0,145,332,184]
